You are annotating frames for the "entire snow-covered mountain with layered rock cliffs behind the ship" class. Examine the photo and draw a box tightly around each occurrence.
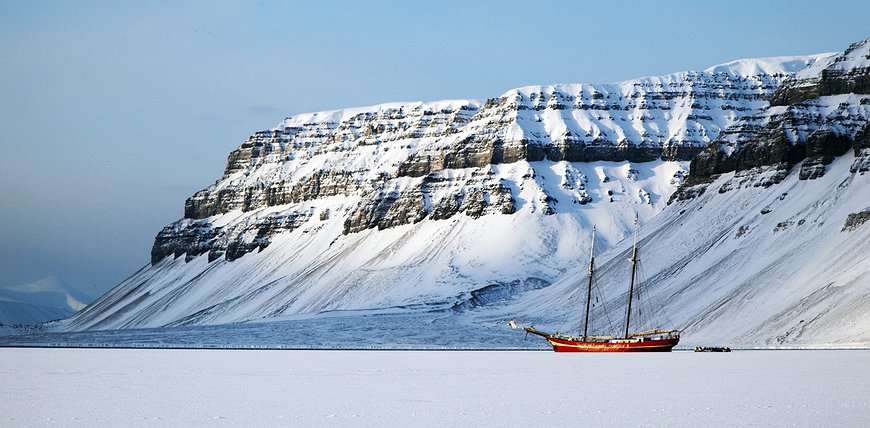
[55,41,870,343]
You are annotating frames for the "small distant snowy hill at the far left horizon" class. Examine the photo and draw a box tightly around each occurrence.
[0,278,94,325]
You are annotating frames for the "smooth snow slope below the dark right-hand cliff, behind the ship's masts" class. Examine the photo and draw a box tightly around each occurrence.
[503,153,870,346]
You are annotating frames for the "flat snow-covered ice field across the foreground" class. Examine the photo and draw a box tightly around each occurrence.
[0,348,870,427]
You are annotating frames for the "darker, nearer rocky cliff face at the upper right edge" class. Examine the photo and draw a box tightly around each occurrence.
[681,39,870,189]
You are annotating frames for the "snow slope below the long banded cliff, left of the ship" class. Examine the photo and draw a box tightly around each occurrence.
[59,161,685,329]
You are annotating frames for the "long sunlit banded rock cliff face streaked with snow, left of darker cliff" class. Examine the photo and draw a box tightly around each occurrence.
[152,55,827,264]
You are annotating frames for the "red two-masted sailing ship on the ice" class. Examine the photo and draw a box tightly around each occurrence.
[525,217,680,352]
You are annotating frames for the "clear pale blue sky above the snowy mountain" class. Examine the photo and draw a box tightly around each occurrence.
[0,0,870,294]
